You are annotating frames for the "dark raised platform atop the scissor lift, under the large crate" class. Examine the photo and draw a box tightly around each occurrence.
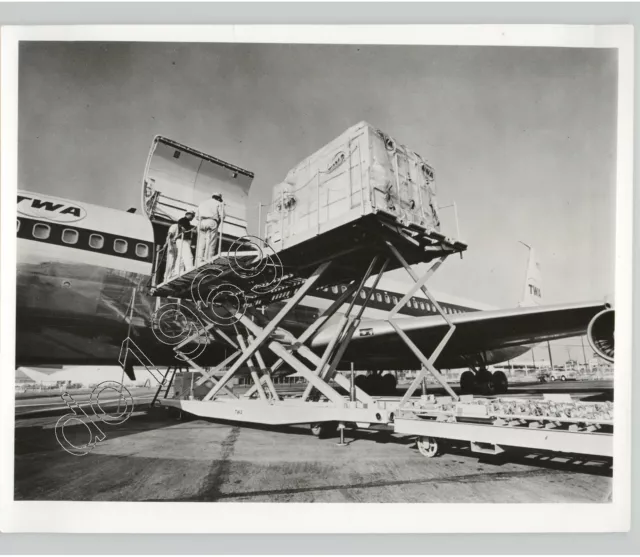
[151,213,467,303]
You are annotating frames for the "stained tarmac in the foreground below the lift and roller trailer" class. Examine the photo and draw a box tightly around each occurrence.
[15,382,612,503]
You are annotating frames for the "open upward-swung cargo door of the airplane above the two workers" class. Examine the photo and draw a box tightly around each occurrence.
[142,136,253,242]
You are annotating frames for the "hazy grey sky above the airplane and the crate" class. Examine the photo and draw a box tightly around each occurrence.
[18,42,617,307]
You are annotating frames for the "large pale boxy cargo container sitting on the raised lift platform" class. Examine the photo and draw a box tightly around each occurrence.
[265,122,440,251]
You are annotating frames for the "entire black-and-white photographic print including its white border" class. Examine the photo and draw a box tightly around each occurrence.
[2,26,633,531]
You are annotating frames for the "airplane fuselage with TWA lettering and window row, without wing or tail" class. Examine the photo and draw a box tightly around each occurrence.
[16,192,530,369]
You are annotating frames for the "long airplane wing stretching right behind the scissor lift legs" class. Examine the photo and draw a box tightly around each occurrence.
[311,302,610,370]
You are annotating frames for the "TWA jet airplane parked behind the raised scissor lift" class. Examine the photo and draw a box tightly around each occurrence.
[16,137,614,393]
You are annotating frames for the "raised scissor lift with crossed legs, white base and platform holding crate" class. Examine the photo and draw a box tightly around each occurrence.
[140,214,466,425]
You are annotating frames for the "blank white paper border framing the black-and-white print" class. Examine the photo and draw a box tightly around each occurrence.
[0,25,634,534]
